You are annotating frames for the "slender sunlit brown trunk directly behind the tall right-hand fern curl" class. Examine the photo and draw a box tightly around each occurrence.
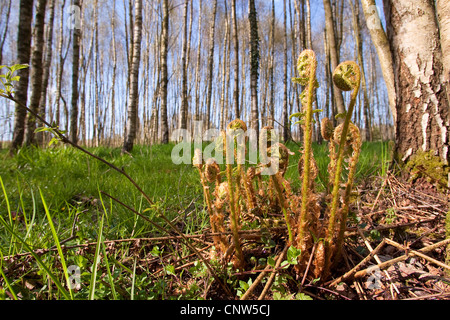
[323,0,345,113]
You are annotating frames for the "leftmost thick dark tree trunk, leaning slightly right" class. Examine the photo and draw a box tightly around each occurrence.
[11,0,33,152]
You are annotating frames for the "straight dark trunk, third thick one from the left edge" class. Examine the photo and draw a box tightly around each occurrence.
[70,0,81,143]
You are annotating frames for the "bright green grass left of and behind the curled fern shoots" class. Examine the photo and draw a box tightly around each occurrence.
[0,142,388,299]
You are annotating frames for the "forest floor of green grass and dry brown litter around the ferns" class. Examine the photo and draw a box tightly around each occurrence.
[0,143,450,300]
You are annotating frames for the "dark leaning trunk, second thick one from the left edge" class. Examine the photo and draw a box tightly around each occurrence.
[36,0,56,146]
